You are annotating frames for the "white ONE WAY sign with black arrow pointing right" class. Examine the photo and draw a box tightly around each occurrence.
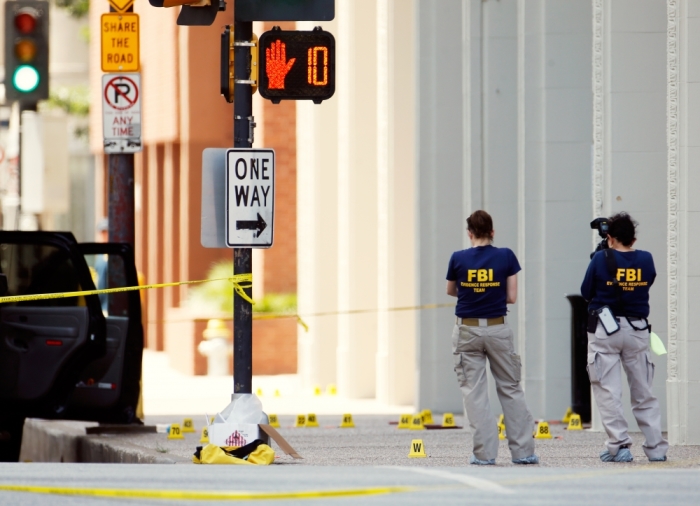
[226,148,275,248]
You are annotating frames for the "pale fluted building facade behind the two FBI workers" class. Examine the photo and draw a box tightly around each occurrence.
[297,0,700,444]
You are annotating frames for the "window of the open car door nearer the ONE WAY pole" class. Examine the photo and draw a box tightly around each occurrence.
[84,253,129,316]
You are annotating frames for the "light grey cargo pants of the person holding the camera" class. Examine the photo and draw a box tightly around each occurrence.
[588,318,668,459]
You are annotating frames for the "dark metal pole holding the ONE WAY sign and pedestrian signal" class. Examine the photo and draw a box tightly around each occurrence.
[233,15,255,394]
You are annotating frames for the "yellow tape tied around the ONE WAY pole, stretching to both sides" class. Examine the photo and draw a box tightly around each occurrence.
[0,273,455,332]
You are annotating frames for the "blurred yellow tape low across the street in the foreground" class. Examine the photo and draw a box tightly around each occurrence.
[0,485,418,501]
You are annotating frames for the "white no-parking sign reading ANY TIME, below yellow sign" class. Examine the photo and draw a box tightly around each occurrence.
[102,74,141,154]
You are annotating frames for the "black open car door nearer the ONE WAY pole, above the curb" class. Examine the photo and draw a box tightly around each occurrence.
[67,243,143,423]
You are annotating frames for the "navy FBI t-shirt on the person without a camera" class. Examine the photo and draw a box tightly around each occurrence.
[447,245,520,318]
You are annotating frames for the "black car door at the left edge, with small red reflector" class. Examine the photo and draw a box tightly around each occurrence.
[0,231,106,460]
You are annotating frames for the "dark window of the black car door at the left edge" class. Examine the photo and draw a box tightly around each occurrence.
[0,243,85,307]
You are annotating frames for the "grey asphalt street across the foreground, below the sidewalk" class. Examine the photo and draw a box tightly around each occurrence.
[0,463,700,506]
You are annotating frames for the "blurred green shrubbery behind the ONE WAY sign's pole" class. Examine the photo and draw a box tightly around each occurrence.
[190,261,297,314]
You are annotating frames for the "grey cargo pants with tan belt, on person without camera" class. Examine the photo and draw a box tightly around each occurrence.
[452,323,535,460]
